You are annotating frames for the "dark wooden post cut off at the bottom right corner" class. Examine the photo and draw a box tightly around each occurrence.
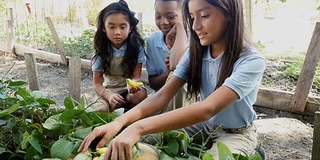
[311,111,320,160]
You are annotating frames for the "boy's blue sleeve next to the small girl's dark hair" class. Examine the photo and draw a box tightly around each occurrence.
[146,37,157,75]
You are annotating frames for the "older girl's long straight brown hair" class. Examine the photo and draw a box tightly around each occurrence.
[183,0,244,98]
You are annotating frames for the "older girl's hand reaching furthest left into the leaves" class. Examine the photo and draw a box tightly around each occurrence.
[78,121,122,152]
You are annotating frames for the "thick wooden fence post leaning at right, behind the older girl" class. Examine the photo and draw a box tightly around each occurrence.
[290,22,320,112]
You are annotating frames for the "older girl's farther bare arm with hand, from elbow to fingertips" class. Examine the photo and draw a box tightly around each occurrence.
[78,77,185,152]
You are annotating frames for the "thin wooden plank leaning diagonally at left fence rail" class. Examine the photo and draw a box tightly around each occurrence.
[44,17,68,65]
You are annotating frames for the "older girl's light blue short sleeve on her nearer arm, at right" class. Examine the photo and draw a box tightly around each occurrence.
[223,54,266,100]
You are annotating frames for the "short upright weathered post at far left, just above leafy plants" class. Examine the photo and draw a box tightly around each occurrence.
[24,53,40,91]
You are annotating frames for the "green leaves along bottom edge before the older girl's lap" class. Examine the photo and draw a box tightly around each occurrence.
[151,127,262,160]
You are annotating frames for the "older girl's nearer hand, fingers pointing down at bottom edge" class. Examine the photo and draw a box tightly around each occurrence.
[104,126,141,160]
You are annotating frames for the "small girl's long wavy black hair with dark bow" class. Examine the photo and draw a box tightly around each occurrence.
[93,0,145,77]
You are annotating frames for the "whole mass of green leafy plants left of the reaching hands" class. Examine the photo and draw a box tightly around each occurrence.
[0,66,118,159]
